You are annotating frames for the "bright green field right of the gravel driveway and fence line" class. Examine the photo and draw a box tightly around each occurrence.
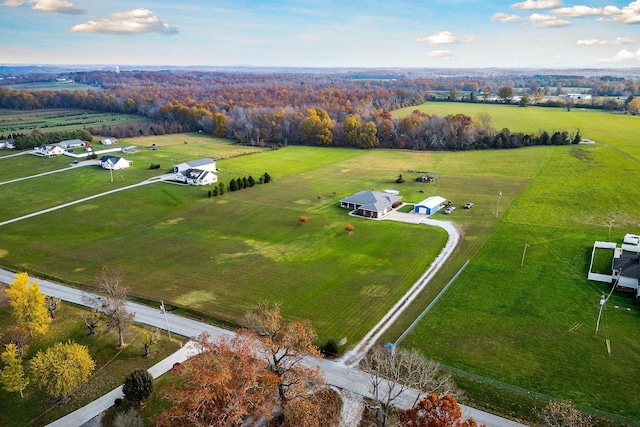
[385,104,640,420]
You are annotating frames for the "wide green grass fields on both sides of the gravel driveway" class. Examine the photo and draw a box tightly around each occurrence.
[0,103,640,420]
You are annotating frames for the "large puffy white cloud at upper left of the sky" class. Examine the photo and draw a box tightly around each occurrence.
[70,8,178,34]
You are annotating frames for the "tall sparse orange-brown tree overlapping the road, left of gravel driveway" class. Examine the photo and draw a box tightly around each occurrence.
[244,301,324,407]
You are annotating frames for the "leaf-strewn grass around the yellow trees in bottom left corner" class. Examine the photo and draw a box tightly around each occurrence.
[0,304,183,427]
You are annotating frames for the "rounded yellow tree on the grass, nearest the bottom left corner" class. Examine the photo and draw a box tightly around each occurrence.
[29,341,95,398]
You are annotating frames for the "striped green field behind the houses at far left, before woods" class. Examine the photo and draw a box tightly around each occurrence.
[0,109,151,136]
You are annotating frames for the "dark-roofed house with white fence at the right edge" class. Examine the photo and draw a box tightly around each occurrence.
[587,234,640,298]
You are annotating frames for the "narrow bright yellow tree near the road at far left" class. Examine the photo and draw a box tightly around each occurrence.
[5,273,51,336]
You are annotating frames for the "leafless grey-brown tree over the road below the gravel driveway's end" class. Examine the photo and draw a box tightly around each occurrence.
[361,346,459,427]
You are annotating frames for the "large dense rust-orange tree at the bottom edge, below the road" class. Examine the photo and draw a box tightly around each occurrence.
[157,333,278,427]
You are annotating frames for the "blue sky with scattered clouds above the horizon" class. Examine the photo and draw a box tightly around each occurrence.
[0,0,640,68]
